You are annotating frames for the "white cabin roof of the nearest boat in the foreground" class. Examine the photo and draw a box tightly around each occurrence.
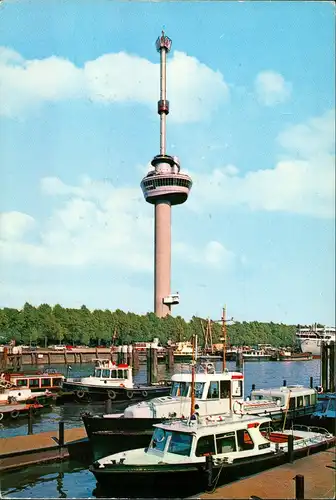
[153,413,272,436]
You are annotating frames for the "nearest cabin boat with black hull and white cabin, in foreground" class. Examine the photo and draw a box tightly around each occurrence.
[90,414,335,496]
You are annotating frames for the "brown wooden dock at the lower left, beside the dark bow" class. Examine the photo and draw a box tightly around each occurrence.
[0,427,91,472]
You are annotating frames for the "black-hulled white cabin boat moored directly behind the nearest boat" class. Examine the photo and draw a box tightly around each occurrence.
[82,363,316,459]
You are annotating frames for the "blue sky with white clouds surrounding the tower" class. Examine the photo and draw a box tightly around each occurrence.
[0,0,335,324]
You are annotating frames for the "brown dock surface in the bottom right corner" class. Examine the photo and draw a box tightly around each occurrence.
[197,447,336,500]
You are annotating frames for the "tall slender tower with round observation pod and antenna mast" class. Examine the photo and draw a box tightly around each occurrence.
[141,32,192,317]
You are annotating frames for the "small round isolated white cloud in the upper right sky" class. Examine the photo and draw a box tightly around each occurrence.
[254,71,292,106]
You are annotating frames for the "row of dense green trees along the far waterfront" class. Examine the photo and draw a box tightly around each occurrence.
[0,303,296,347]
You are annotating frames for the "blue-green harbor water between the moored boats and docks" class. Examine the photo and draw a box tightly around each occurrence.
[0,360,320,498]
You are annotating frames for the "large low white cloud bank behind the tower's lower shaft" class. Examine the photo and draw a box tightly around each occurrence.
[0,176,230,272]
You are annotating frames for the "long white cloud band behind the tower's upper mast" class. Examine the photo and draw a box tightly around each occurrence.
[0,47,229,122]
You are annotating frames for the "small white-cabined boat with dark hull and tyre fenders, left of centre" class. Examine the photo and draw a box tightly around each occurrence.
[62,359,170,401]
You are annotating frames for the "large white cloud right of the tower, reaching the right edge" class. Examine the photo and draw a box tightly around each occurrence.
[187,111,335,217]
